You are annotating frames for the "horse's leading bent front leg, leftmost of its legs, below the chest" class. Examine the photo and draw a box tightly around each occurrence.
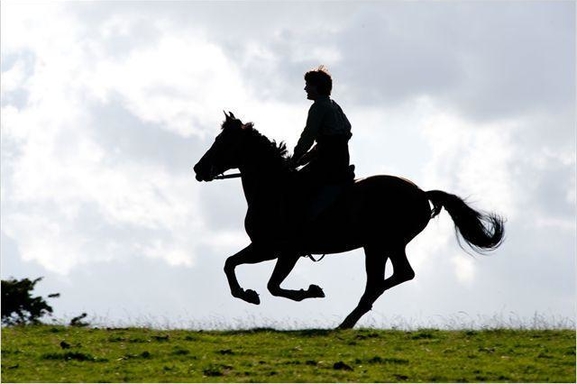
[224,244,275,305]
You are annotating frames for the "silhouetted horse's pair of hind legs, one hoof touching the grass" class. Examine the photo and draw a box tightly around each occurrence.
[339,246,415,329]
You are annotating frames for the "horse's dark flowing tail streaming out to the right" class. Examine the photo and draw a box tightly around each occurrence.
[426,191,505,253]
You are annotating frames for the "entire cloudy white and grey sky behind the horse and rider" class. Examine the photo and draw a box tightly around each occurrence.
[1,1,576,328]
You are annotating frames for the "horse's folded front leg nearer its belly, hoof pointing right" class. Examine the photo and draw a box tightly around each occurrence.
[267,253,325,301]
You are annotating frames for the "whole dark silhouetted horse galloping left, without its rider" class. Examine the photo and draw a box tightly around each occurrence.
[194,112,504,329]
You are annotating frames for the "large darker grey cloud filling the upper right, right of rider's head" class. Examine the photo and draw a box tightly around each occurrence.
[332,2,575,119]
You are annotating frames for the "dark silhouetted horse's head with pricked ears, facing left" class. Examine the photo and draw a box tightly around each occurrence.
[194,112,252,181]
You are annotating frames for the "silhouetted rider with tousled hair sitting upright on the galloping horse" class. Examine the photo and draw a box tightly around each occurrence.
[292,65,354,218]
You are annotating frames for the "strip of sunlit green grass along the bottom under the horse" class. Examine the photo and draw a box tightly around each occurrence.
[1,326,575,382]
